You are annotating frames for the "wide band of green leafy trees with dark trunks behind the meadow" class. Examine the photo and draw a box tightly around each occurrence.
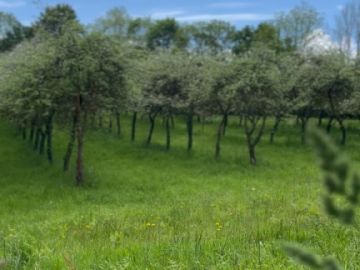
[0,4,360,185]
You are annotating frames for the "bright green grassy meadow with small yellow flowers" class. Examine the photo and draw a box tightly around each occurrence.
[0,115,360,270]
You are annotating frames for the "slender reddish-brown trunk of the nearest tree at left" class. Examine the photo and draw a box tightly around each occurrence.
[76,94,84,186]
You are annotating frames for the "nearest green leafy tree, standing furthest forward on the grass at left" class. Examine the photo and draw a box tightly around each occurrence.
[58,25,126,185]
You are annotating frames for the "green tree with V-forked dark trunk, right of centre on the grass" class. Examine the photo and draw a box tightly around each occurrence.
[232,47,281,165]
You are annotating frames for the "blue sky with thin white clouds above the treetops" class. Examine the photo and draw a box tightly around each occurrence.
[0,0,347,29]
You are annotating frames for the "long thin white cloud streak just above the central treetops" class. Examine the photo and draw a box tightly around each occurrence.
[176,13,272,22]
